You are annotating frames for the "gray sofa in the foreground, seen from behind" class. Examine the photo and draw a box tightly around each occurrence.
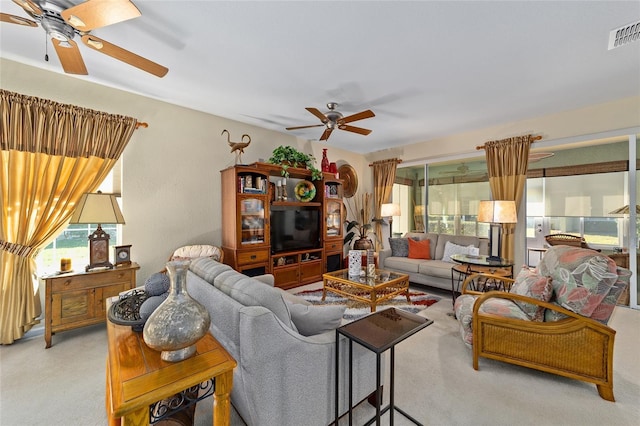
[187,258,384,426]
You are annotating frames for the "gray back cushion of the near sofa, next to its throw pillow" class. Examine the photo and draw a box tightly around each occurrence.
[214,271,298,331]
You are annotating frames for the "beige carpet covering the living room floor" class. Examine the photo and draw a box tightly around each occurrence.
[0,286,640,426]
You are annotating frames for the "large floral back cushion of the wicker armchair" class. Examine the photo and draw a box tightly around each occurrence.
[538,246,618,317]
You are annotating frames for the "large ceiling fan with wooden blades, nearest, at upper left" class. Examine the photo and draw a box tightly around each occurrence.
[0,0,169,77]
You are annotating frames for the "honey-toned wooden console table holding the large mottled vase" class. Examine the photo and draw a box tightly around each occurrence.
[106,321,237,426]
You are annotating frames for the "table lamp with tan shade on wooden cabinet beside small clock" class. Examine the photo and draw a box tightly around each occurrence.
[69,191,124,271]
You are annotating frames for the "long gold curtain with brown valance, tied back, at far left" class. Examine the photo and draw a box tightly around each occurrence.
[0,89,136,344]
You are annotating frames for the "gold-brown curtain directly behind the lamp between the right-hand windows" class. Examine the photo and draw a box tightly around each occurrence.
[484,135,538,259]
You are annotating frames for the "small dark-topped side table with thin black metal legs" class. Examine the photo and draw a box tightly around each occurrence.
[334,308,433,425]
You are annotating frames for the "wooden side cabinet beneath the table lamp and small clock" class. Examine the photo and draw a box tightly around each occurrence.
[43,263,140,348]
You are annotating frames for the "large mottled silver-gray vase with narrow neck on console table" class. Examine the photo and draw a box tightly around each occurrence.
[142,260,211,362]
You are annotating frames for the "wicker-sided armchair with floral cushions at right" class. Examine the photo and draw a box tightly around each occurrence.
[455,246,631,401]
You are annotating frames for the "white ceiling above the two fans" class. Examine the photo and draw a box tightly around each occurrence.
[0,0,640,153]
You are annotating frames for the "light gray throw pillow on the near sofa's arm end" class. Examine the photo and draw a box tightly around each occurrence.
[287,301,347,336]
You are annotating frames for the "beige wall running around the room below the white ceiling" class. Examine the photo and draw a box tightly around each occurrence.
[0,58,640,282]
